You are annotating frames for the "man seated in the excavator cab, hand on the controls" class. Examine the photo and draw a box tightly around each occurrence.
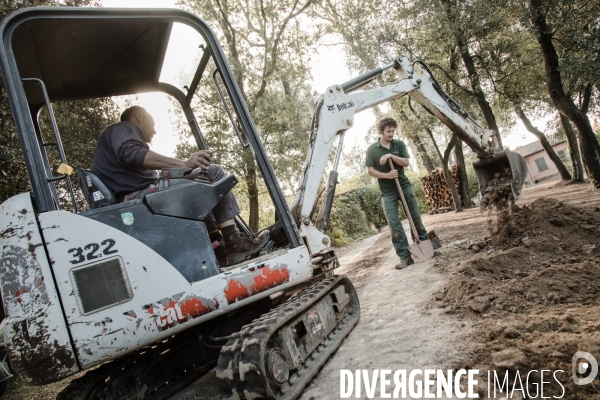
[92,106,269,268]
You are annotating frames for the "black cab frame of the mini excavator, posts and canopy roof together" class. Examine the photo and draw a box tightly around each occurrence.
[0,7,302,247]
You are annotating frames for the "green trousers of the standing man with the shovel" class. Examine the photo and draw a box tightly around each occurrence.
[381,186,428,258]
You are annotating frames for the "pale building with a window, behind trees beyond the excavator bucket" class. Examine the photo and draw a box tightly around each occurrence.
[513,135,571,183]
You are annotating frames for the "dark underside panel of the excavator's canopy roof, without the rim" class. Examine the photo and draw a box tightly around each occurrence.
[13,19,171,102]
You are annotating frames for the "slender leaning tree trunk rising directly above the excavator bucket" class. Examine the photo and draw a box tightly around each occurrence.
[442,0,502,147]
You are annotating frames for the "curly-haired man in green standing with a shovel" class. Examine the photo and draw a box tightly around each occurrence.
[365,117,428,269]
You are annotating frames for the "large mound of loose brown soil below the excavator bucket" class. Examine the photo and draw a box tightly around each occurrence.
[435,198,600,399]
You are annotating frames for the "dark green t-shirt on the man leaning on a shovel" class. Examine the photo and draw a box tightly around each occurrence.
[365,139,410,194]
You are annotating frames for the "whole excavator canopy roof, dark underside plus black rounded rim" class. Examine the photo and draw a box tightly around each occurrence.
[0,7,212,109]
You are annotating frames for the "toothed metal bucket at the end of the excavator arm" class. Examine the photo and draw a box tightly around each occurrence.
[473,149,527,201]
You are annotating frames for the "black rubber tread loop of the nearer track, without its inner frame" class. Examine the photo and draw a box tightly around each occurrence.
[216,275,360,400]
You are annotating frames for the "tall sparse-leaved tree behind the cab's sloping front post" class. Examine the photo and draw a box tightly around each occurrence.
[182,0,315,230]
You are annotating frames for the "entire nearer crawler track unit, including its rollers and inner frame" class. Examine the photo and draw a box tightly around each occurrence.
[216,275,360,400]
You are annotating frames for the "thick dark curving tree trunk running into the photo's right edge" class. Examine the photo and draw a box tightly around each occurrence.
[530,0,600,188]
